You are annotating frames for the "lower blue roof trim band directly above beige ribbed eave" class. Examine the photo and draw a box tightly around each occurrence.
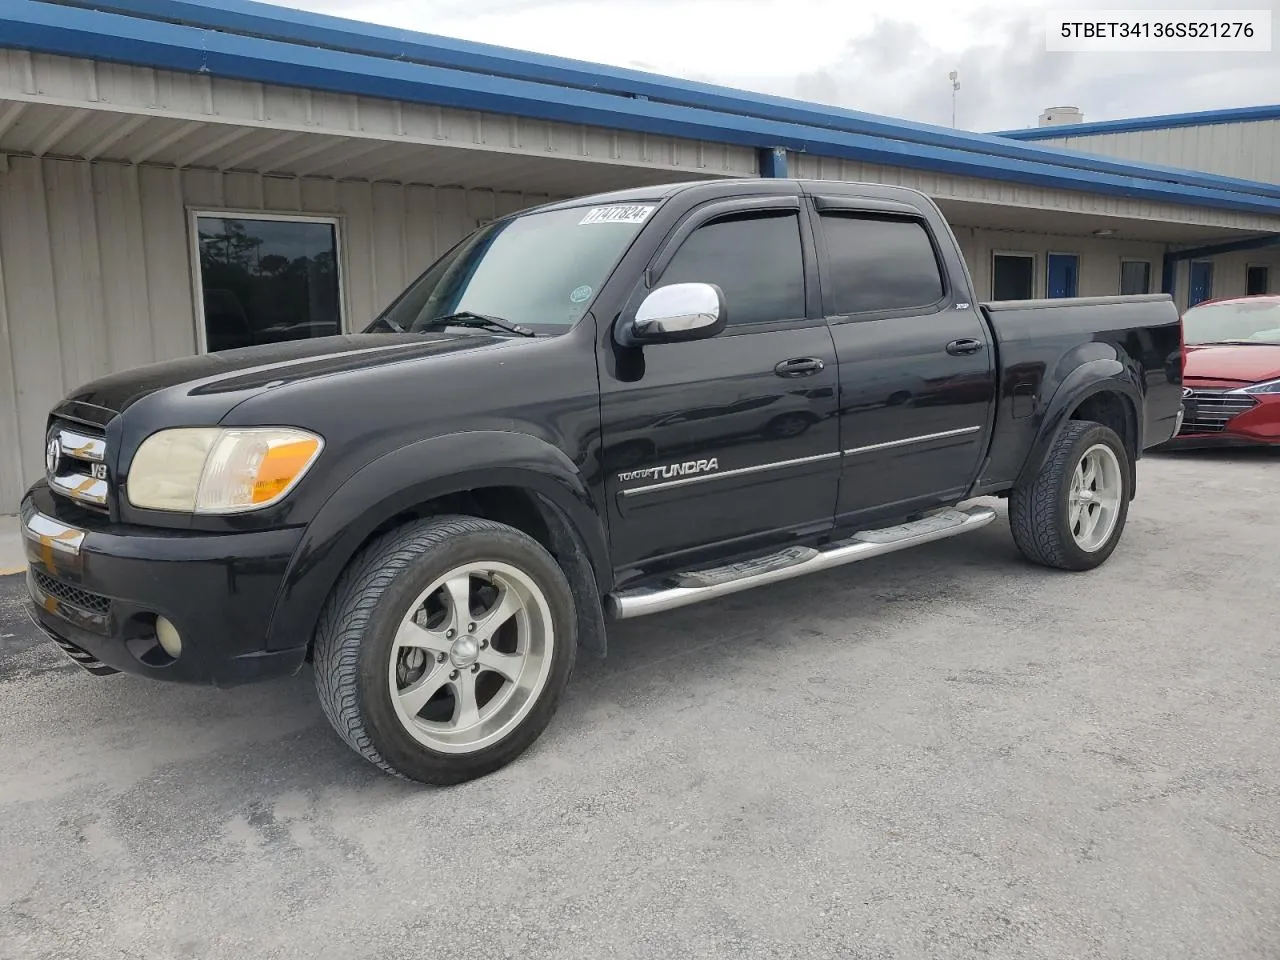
[0,0,1280,216]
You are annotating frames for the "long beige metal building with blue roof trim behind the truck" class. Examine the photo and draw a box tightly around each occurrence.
[0,0,1280,513]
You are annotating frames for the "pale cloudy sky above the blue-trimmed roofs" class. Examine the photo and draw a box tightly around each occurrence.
[289,0,1280,132]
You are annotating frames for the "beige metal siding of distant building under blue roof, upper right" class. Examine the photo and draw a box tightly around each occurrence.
[1037,120,1280,183]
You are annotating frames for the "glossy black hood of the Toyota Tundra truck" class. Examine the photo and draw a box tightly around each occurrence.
[67,332,506,413]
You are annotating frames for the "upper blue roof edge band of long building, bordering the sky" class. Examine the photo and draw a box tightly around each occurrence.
[32,0,1280,198]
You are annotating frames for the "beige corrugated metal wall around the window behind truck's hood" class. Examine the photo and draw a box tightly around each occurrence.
[0,159,560,513]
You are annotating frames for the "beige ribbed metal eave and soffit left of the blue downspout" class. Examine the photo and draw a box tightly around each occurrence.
[0,49,759,187]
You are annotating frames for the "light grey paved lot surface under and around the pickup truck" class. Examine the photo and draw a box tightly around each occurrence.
[0,453,1280,960]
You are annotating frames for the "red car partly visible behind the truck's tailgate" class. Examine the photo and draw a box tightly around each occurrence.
[1169,296,1280,447]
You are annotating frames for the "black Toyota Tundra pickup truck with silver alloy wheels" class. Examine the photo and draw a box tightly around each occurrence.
[20,179,1181,783]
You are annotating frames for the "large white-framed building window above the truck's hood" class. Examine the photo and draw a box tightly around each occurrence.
[195,214,342,351]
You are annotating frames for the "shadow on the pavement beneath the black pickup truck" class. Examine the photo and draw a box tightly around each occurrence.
[0,517,1090,803]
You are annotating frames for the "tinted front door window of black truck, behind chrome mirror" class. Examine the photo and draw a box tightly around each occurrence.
[658,212,805,326]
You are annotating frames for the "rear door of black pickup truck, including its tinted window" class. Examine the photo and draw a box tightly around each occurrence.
[810,197,996,527]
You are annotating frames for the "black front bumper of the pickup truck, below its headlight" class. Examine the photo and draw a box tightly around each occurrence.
[20,484,306,686]
